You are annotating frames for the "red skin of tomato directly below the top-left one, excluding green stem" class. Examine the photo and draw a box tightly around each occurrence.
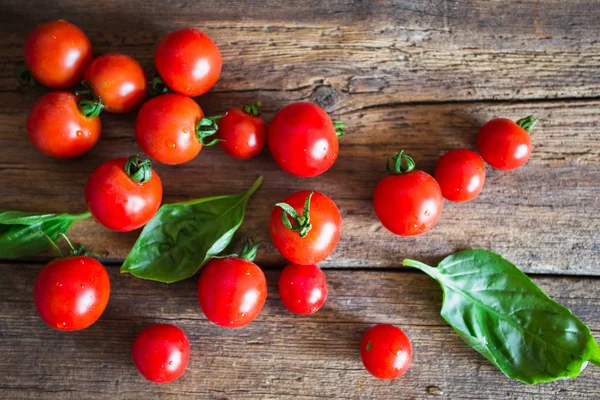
[26,91,101,158]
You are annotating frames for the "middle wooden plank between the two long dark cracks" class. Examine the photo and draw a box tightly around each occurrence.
[0,99,600,275]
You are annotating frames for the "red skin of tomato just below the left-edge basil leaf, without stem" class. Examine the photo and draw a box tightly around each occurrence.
[33,256,110,331]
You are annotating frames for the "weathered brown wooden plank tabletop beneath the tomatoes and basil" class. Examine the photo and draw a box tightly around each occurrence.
[0,0,600,399]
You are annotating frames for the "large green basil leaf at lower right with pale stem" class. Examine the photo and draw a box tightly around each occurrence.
[403,250,600,384]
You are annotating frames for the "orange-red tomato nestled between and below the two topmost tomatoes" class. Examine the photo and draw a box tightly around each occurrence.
[83,53,147,113]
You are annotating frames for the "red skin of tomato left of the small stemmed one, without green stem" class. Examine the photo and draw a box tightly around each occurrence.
[135,93,204,165]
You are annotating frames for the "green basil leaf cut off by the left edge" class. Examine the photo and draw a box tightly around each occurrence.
[0,211,91,258]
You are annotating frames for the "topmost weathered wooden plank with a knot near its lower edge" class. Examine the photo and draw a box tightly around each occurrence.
[0,0,600,104]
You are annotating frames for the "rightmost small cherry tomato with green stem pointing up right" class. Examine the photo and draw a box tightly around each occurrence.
[477,116,537,171]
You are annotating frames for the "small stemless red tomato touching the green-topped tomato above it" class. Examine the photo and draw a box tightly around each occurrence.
[279,264,327,314]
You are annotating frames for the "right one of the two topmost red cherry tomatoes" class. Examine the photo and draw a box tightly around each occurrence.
[154,28,223,97]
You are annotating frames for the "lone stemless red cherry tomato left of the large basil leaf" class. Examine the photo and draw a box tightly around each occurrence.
[360,324,412,380]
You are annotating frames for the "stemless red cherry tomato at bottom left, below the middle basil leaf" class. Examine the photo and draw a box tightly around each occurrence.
[131,324,190,383]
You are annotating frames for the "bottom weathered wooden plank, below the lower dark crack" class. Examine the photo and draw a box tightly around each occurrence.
[0,263,600,399]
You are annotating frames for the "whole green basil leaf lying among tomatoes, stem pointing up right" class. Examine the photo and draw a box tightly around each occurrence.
[121,176,262,283]
